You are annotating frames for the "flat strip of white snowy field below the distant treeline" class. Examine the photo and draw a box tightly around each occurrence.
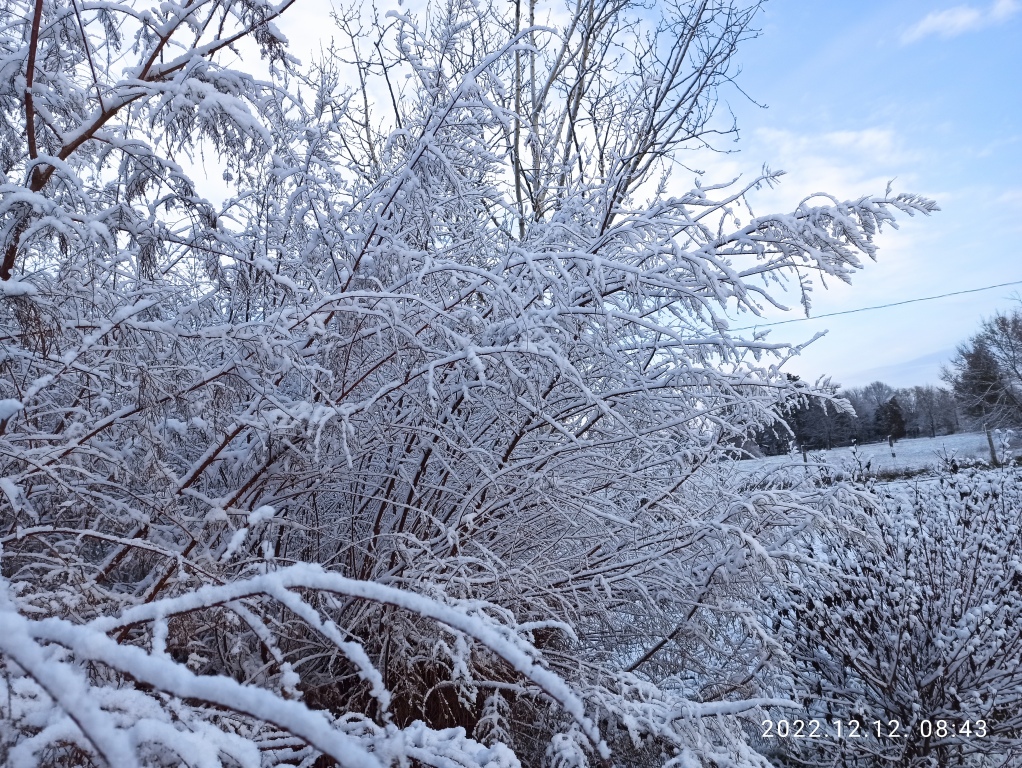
[738,433,1000,480]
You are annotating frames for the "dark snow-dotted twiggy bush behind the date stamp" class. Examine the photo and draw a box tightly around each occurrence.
[774,469,1022,768]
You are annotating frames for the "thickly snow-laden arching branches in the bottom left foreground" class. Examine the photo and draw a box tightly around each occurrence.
[0,564,568,768]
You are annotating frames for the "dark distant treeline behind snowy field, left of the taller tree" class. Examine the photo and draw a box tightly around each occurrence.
[755,381,961,456]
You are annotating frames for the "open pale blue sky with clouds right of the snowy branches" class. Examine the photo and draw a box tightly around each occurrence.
[715,0,1022,386]
